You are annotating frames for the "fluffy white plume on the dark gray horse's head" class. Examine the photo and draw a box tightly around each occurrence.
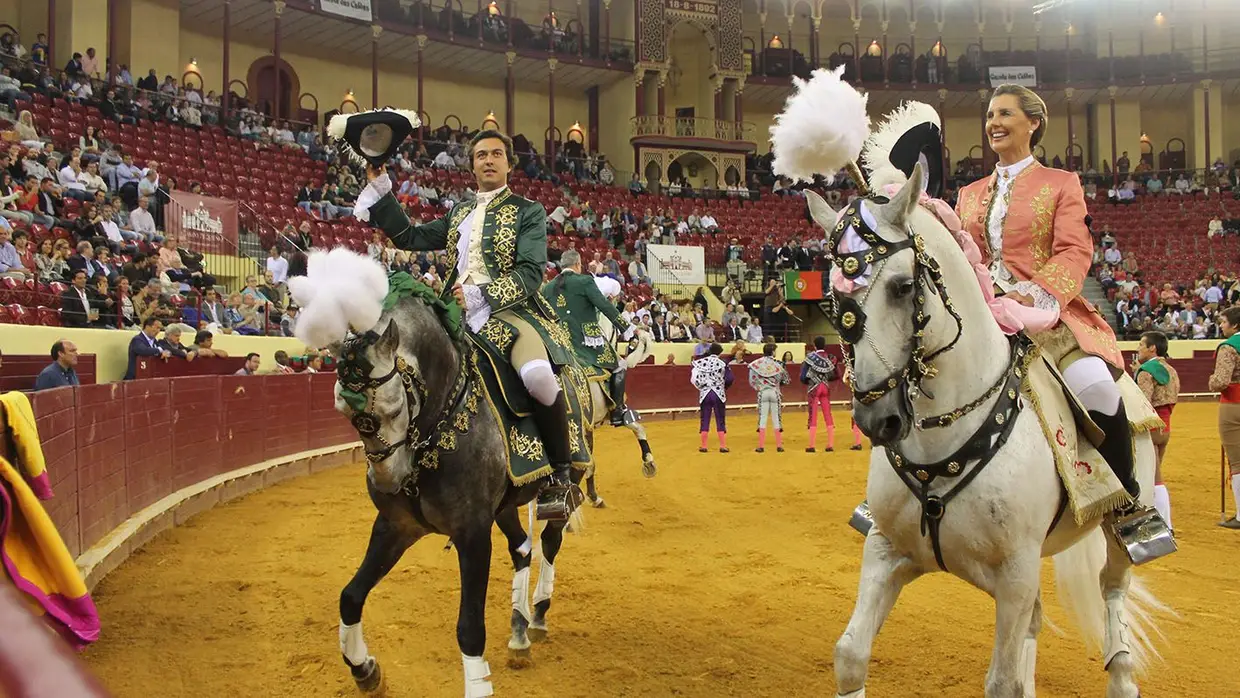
[289,247,388,347]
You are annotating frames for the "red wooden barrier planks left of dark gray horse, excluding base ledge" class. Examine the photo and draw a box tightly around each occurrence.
[31,373,357,557]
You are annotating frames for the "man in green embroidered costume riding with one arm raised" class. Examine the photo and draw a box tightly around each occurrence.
[358,130,582,519]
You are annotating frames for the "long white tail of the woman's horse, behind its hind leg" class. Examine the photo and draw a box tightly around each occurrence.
[1053,526,1172,673]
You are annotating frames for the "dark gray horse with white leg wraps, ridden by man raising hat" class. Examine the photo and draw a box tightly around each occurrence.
[314,286,655,698]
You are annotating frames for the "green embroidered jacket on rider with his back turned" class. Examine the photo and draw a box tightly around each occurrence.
[543,272,629,371]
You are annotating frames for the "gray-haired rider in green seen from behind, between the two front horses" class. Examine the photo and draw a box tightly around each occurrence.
[543,249,632,426]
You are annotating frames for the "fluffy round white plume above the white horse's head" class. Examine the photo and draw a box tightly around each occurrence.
[770,66,869,181]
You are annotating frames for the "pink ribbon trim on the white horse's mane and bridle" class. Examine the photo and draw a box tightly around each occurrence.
[831,185,1059,335]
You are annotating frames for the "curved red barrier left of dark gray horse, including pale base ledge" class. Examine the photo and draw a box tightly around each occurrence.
[24,373,362,586]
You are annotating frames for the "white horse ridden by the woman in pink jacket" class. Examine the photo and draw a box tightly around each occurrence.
[806,165,1162,698]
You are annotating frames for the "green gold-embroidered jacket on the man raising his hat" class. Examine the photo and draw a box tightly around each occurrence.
[371,188,573,366]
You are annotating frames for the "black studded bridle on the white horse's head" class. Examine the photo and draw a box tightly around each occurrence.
[823,196,963,414]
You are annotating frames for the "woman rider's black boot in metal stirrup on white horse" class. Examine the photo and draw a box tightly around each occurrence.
[1089,400,1176,564]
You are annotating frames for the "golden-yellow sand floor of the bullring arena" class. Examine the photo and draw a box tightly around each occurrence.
[86,404,1240,698]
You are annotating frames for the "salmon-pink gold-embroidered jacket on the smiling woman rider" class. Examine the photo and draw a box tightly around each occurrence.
[956,161,1123,371]
